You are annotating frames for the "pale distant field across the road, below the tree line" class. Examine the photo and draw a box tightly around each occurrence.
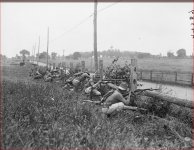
[38,58,193,72]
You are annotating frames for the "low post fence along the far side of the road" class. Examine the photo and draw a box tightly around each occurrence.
[138,70,194,86]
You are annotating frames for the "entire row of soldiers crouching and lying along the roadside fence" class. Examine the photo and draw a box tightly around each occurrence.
[31,64,145,115]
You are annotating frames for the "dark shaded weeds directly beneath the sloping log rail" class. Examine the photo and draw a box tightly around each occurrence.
[130,95,194,128]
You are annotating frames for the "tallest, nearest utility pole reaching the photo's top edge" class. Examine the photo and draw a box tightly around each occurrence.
[94,0,98,71]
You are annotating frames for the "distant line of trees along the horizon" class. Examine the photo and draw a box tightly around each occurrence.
[10,48,187,62]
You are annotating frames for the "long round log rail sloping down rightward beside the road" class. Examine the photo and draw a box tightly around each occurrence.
[145,91,194,109]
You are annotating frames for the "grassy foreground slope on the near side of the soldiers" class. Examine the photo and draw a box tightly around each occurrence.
[2,65,192,150]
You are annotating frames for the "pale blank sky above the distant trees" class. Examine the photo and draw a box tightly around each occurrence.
[1,2,193,57]
